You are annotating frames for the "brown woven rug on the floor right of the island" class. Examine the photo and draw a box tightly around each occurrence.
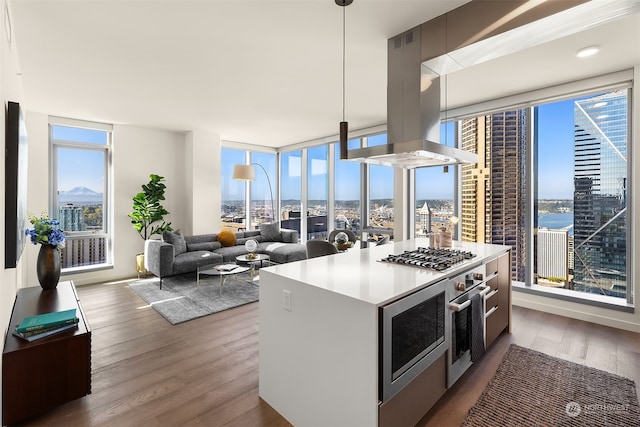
[463,344,640,427]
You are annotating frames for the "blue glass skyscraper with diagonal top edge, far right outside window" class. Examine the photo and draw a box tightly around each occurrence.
[573,91,628,297]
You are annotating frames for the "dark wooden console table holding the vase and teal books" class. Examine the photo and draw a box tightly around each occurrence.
[2,281,91,425]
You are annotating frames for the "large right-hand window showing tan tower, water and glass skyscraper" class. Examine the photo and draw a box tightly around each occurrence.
[460,78,632,302]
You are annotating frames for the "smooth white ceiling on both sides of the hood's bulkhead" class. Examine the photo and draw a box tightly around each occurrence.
[10,0,640,147]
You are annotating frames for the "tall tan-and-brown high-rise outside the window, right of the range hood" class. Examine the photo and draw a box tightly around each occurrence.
[460,109,527,281]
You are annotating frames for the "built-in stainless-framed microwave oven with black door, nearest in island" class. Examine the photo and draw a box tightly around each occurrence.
[379,280,451,402]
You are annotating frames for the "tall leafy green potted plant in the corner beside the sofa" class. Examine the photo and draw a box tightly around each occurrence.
[128,174,173,274]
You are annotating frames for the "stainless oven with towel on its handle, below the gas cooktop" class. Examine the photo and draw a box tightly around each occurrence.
[447,265,491,387]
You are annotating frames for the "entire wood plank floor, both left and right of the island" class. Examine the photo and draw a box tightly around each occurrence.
[17,284,640,427]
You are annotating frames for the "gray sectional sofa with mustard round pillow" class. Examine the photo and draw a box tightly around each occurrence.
[145,224,307,288]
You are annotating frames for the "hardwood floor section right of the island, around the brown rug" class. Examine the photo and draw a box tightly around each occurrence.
[418,306,640,426]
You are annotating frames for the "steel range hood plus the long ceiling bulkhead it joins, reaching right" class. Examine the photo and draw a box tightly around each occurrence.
[340,0,608,169]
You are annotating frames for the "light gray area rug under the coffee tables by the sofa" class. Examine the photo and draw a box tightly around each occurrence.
[128,273,259,325]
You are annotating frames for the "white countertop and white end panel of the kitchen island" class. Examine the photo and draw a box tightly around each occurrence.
[259,239,509,426]
